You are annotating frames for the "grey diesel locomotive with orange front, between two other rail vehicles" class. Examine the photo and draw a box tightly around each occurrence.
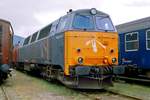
[14,8,118,89]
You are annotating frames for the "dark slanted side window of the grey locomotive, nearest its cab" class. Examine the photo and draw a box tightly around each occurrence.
[38,24,52,40]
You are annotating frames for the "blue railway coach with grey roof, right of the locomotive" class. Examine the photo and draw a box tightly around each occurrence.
[116,17,150,76]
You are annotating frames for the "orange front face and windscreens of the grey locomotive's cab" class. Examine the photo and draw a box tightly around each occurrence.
[64,9,118,75]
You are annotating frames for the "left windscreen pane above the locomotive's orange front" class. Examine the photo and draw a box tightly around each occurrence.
[72,14,94,29]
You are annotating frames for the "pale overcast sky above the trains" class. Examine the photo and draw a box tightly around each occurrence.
[0,0,150,37]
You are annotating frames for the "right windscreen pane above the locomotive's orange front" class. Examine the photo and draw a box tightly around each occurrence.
[96,16,115,31]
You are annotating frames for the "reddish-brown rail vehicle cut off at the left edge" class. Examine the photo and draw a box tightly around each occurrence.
[0,19,14,83]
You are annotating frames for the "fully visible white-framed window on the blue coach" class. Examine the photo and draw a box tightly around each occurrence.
[125,32,139,51]
